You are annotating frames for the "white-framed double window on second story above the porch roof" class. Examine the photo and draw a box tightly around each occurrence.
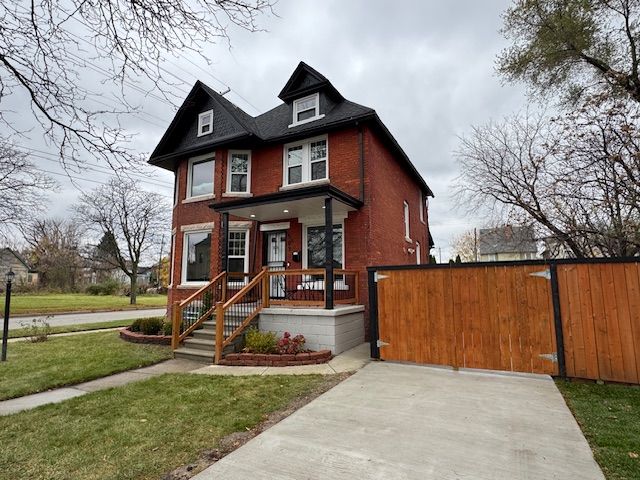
[284,136,329,185]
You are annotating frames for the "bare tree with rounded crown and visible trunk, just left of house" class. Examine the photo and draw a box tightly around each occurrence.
[74,179,170,304]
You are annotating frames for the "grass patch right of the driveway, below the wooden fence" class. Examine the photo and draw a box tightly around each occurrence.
[556,380,640,480]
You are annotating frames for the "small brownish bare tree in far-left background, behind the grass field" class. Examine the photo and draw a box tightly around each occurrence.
[21,218,83,292]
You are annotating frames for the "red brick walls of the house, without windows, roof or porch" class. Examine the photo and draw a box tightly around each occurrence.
[169,127,429,330]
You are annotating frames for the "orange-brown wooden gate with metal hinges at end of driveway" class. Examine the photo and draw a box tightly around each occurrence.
[378,265,558,375]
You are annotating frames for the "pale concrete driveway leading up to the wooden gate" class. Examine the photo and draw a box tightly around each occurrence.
[194,362,604,480]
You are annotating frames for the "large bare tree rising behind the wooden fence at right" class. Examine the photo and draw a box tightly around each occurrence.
[457,98,640,257]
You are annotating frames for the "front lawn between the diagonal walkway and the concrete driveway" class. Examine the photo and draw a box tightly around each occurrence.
[0,374,328,480]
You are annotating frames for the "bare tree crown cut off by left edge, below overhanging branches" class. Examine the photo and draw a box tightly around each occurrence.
[0,141,56,240]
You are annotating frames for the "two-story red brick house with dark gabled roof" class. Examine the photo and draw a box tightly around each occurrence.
[149,62,433,362]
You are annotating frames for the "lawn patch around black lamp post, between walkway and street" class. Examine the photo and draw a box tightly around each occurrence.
[0,332,171,400]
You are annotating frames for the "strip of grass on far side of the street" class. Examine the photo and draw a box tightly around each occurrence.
[0,293,167,315]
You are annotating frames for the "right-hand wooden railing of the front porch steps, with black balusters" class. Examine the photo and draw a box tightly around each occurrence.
[215,267,269,363]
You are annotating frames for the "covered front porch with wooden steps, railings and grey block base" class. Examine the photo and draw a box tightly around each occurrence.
[172,184,366,363]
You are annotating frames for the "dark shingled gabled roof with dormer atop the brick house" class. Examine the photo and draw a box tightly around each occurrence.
[149,62,433,196]
